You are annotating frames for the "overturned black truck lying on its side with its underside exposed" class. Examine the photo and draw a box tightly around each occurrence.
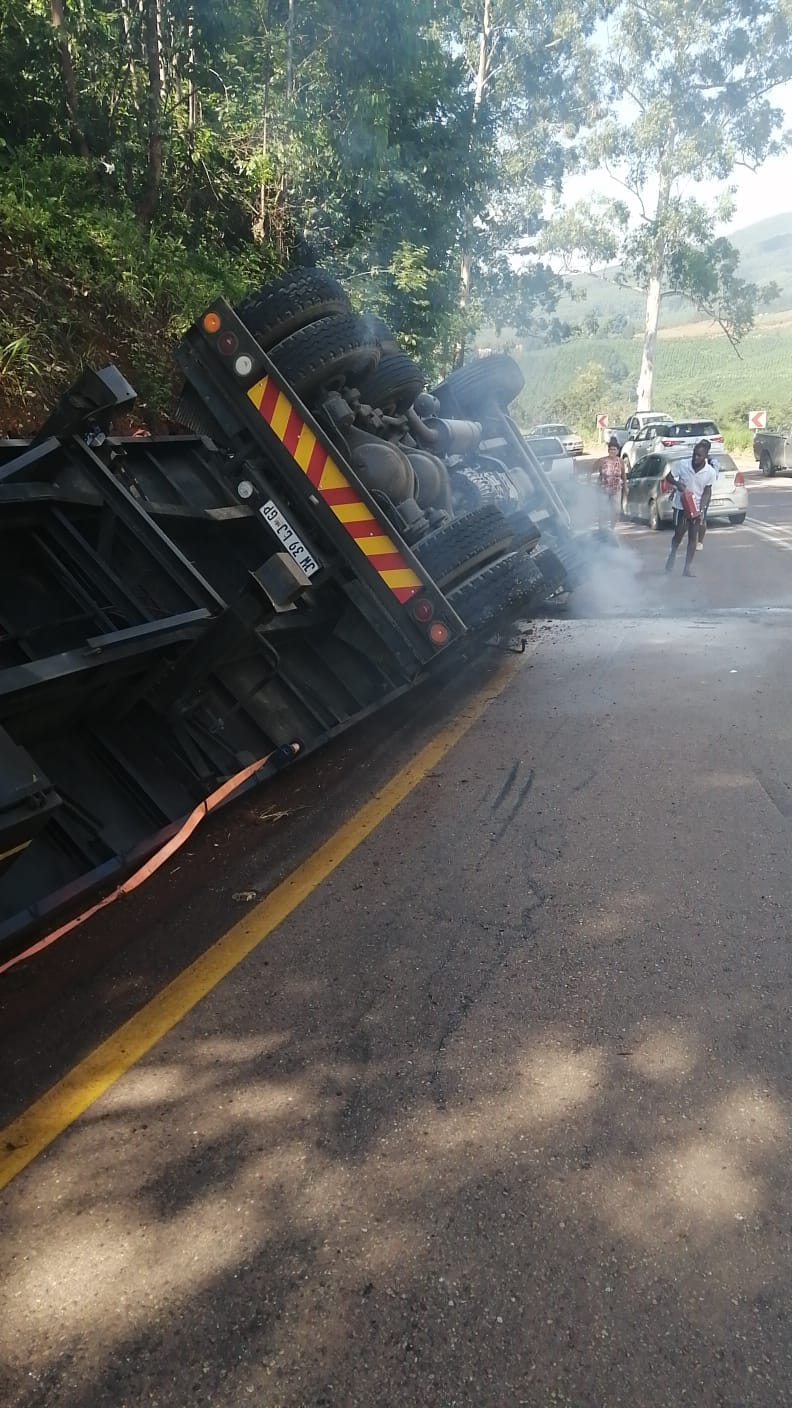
[0,270,579,970]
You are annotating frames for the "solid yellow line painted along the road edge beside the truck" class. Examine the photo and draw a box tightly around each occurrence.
[0,660,516,1188]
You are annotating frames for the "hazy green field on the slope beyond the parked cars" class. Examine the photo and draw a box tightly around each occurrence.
[504,321,792,446]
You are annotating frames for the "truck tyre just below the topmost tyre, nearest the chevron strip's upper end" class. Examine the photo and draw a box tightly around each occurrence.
[269,313,379,396]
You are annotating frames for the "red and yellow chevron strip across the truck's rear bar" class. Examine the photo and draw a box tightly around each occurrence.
[248,376,423,601]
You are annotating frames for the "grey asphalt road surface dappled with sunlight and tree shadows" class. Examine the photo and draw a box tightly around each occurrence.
[0,467,792,1408]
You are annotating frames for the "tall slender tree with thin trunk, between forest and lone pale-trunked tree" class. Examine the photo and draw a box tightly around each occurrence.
[445,0,600,362]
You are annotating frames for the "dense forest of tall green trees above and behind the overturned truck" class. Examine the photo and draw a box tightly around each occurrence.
[0,0,792,434]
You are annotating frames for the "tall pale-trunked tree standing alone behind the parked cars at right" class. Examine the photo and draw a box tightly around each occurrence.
[545,0,792,410]
